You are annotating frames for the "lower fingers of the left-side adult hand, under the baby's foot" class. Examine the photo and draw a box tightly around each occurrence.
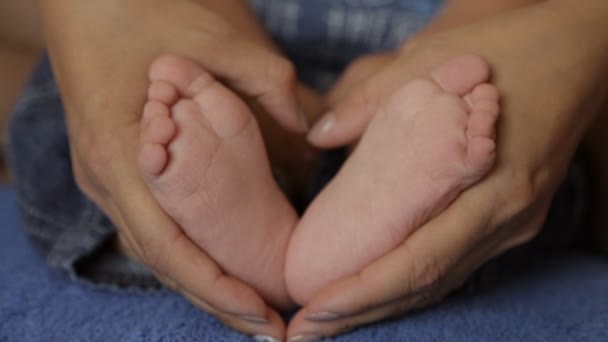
[104,164,284,336]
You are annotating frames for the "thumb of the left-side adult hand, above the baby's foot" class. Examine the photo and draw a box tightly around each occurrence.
[180,8,308,132]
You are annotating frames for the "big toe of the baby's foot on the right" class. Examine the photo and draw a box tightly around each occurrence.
[431,55,490,96]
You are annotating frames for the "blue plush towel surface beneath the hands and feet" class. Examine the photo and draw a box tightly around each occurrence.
[0,188,608,342]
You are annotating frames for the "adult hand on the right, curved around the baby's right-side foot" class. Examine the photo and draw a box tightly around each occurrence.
[288,0,608,340]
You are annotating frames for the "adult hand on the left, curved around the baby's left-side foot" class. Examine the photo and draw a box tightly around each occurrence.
[38,0,314,339]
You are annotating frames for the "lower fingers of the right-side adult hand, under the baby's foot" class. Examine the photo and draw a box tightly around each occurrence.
[288,166,552,336]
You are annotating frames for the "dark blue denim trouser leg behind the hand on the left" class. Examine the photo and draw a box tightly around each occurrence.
[8,59,157,287]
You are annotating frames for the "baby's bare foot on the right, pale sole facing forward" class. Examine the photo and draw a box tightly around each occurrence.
[286,56,499,305]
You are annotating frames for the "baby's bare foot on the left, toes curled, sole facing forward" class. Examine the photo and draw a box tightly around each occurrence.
[139,56,297,308]
